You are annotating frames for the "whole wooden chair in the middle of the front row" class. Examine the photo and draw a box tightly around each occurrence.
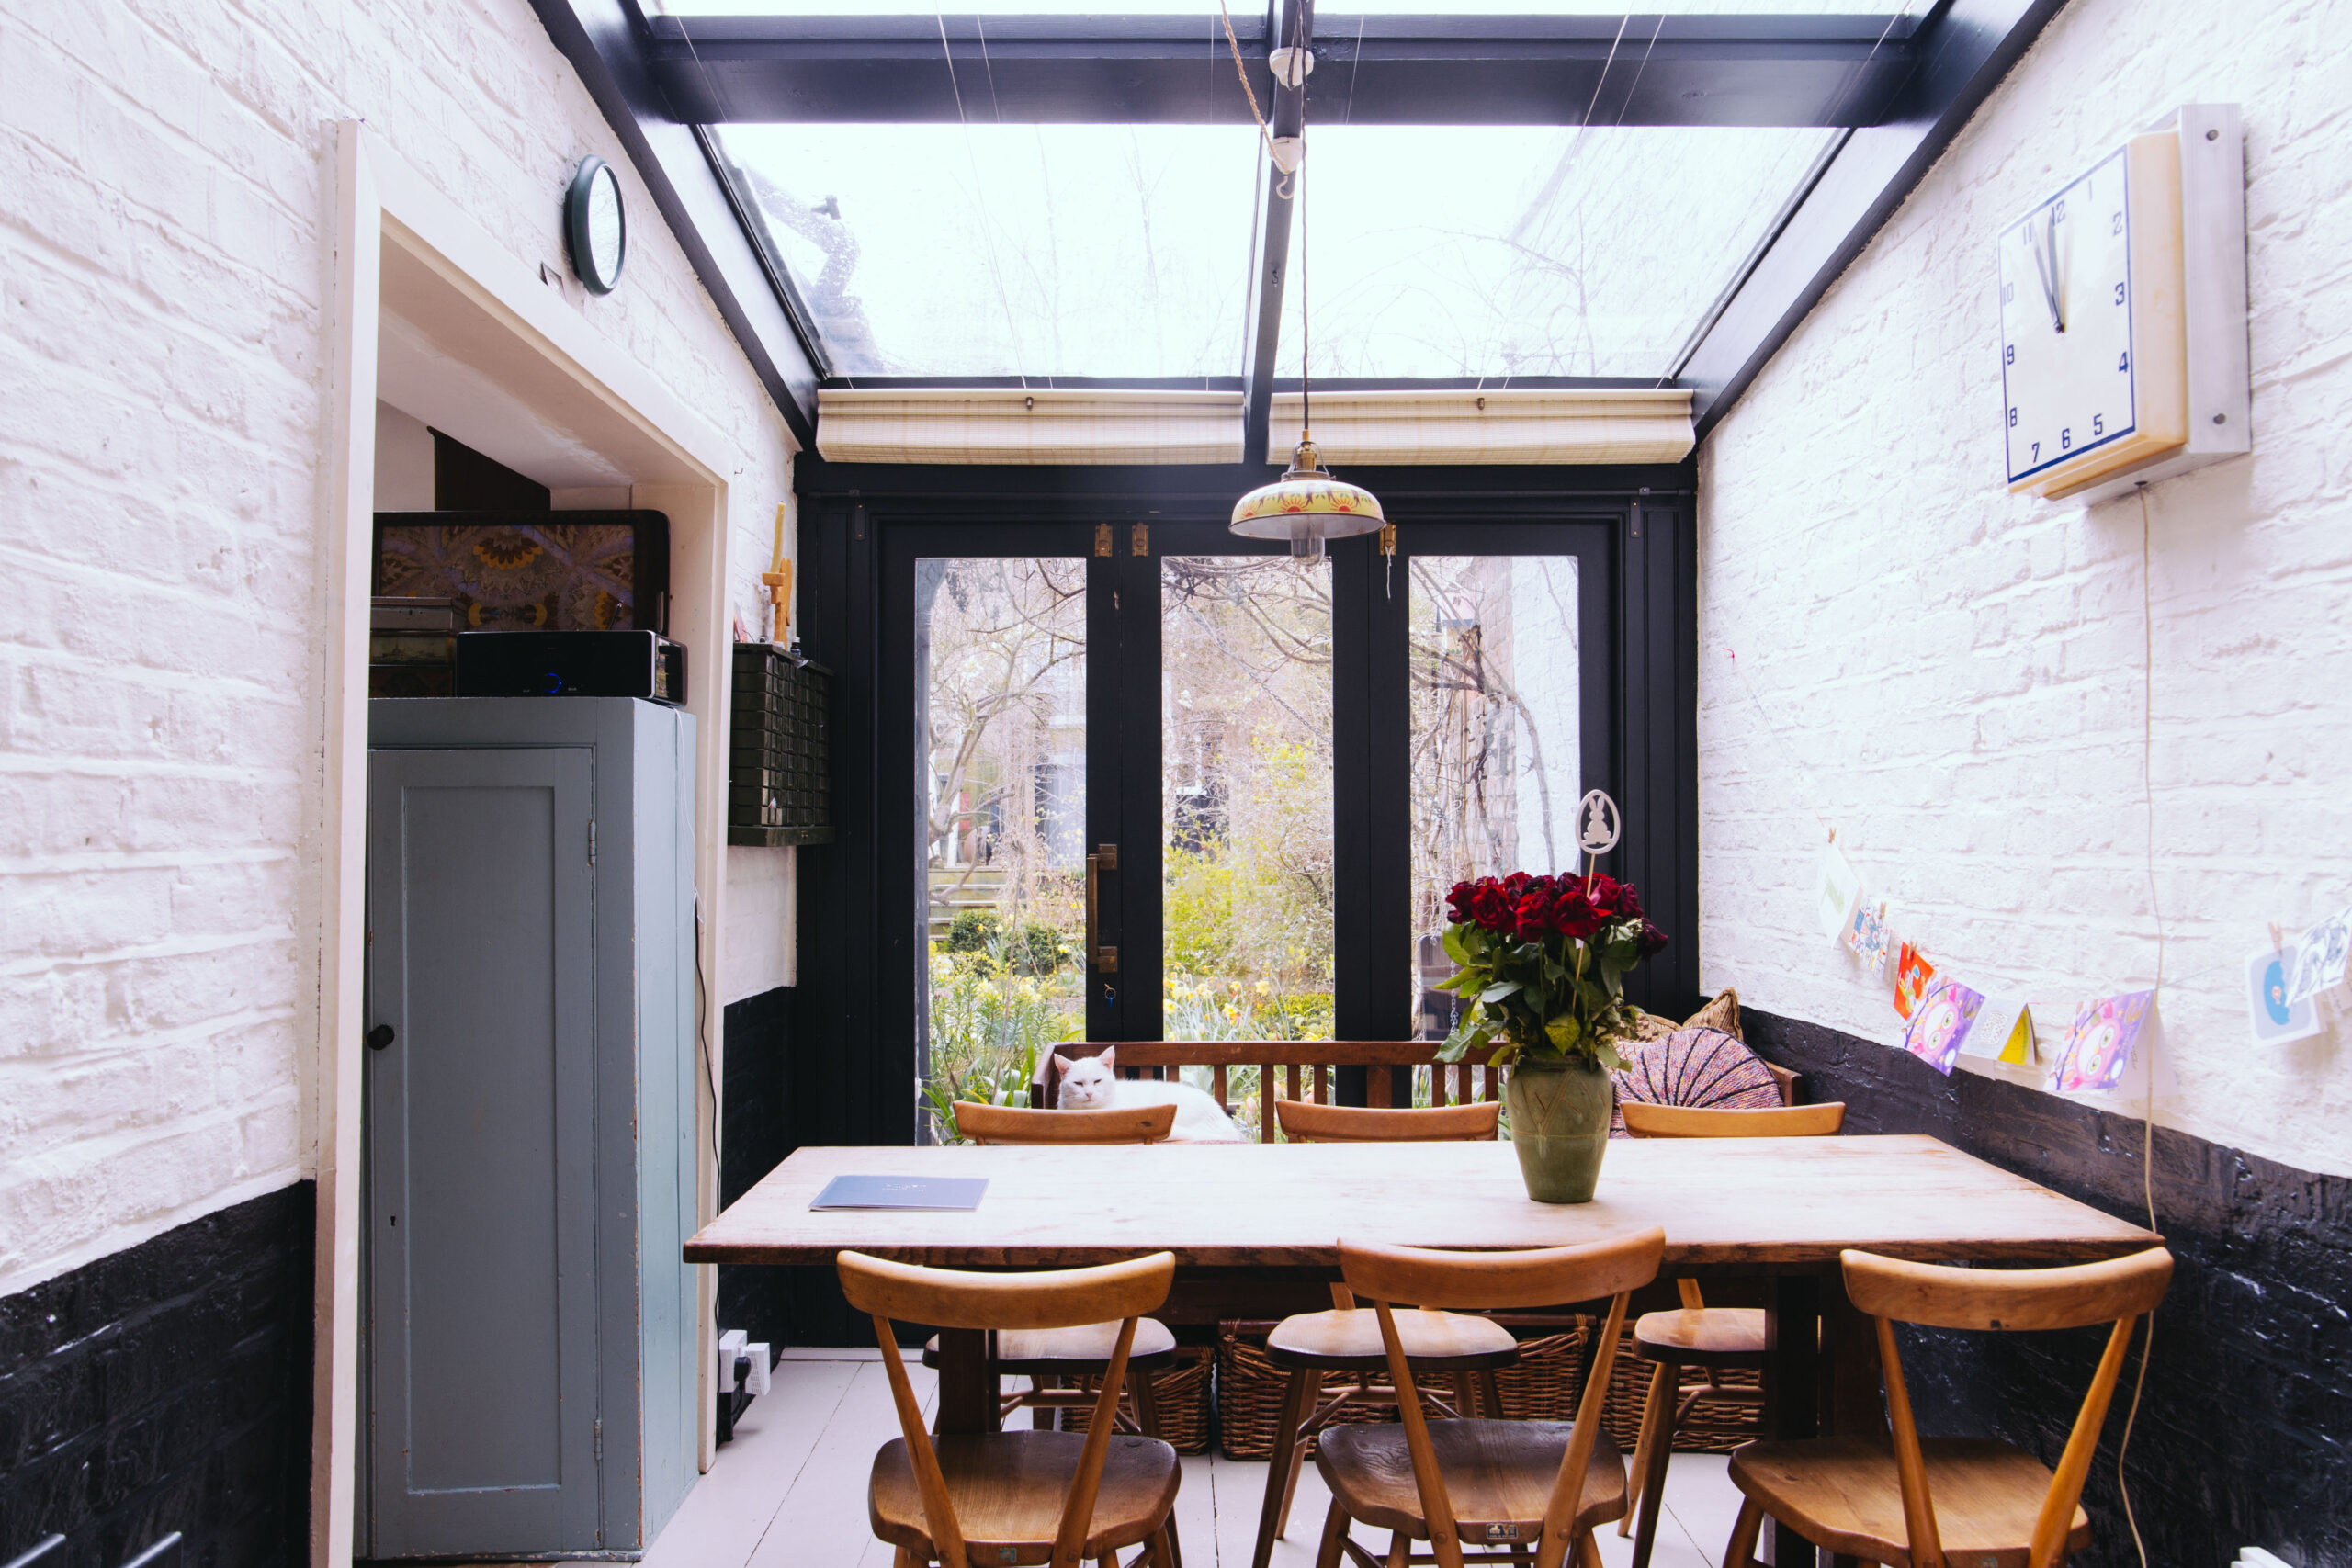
[1315,1227,1665,1568]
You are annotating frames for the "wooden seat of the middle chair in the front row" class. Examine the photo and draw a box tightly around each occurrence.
[1315,1420,1625,1547]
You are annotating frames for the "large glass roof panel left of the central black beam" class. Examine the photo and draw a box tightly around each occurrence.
[713,125,1261,378]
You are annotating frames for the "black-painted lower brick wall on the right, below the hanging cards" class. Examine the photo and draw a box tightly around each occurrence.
[1743,1010,2352,1568]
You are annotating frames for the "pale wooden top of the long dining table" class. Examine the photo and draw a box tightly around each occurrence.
[687,1135,2159,1267]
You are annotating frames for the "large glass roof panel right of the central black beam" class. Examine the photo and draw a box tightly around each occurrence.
[1277,125,1837,378]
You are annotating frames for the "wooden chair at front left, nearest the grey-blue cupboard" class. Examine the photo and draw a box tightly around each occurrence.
[840,1253,1183,1568]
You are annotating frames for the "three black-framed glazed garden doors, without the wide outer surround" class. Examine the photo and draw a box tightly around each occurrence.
[875,517,1616,1131]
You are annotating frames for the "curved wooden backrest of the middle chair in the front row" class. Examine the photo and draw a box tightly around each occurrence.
[1339,1224,1665,1568]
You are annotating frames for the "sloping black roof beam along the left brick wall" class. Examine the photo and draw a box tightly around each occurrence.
[532,0,820,451]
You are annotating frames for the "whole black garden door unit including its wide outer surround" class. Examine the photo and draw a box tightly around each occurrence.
[778,463,1698,1161]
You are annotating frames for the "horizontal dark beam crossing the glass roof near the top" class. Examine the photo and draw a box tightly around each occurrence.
[647,14,1917,127]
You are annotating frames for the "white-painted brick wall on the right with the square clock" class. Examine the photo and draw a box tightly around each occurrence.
[1698,0,2352,1173]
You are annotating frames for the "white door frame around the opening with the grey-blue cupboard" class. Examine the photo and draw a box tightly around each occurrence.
[311,120,734,1568]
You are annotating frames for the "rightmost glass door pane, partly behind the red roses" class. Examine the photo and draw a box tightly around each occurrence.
[1411,555,1583,1039]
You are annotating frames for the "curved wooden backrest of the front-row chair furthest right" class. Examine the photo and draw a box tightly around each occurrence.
[1844,1246,2173,1568]
